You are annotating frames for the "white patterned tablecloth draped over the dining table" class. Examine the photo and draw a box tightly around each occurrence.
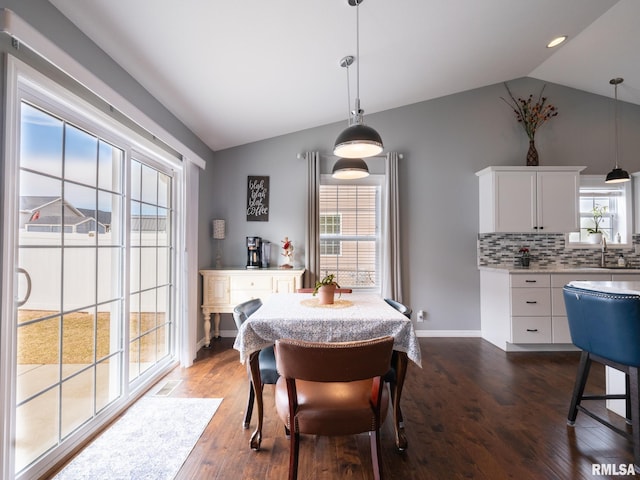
[233,293,422,366]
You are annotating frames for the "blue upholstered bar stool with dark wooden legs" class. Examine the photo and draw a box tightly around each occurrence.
[563,285,640,472]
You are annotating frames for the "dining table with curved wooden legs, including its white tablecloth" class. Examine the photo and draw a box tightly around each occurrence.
[233,292,422,451]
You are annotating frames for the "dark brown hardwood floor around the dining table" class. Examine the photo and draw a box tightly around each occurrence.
[84,338,633,480]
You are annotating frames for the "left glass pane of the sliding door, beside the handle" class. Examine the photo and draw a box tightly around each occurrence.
[15,102,125,472]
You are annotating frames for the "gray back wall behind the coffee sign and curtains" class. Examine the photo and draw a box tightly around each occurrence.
[204,78,640,334]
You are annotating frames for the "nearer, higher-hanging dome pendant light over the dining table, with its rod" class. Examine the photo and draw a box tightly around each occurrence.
[333,0,383,159]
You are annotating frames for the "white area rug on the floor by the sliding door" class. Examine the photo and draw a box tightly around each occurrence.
[54,395,222,480]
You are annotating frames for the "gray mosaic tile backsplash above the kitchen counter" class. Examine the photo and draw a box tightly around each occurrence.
[478,233,640,267]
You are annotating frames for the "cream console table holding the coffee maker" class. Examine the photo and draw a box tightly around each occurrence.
[200,267,305,348]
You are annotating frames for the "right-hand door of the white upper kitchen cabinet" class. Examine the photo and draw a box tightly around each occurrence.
[537,172,580,233]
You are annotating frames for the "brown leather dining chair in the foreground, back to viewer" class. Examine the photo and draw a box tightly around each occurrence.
[275,337,393,480]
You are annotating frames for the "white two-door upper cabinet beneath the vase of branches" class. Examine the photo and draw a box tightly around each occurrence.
[476,167,584,233]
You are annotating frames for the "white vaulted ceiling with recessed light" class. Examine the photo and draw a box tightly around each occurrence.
[50,0,640,150]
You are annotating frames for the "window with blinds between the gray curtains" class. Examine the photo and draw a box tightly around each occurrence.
[319,183,381,289]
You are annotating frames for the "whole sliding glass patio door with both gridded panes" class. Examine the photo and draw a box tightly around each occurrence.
[8,74,176,474]
